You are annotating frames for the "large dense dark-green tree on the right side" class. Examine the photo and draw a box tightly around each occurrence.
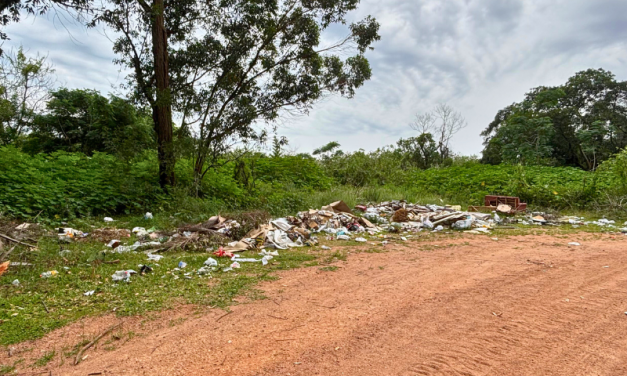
[482,69,627,170]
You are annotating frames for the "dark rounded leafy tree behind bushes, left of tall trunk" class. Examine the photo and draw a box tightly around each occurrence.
[24,89,154,157]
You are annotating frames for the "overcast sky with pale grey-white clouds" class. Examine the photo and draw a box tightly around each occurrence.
[3,0,627,155]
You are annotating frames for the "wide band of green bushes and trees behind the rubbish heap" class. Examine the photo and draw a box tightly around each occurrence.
[0,50,627,222]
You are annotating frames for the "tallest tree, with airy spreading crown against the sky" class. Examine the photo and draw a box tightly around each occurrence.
[96,0,379,191]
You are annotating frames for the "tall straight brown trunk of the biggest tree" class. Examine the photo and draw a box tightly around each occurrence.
[152,0,176,189]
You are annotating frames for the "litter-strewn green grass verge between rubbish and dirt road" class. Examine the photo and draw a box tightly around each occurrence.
[0,209,624,346]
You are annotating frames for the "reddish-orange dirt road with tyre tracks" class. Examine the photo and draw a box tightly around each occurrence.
[0,234,627,376]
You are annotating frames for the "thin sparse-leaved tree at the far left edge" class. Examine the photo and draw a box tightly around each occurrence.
[0,47,54,145]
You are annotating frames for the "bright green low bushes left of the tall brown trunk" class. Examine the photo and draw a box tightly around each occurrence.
[0,147,162,218]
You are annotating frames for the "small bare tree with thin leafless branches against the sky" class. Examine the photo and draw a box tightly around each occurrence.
[410,103,467,161]
